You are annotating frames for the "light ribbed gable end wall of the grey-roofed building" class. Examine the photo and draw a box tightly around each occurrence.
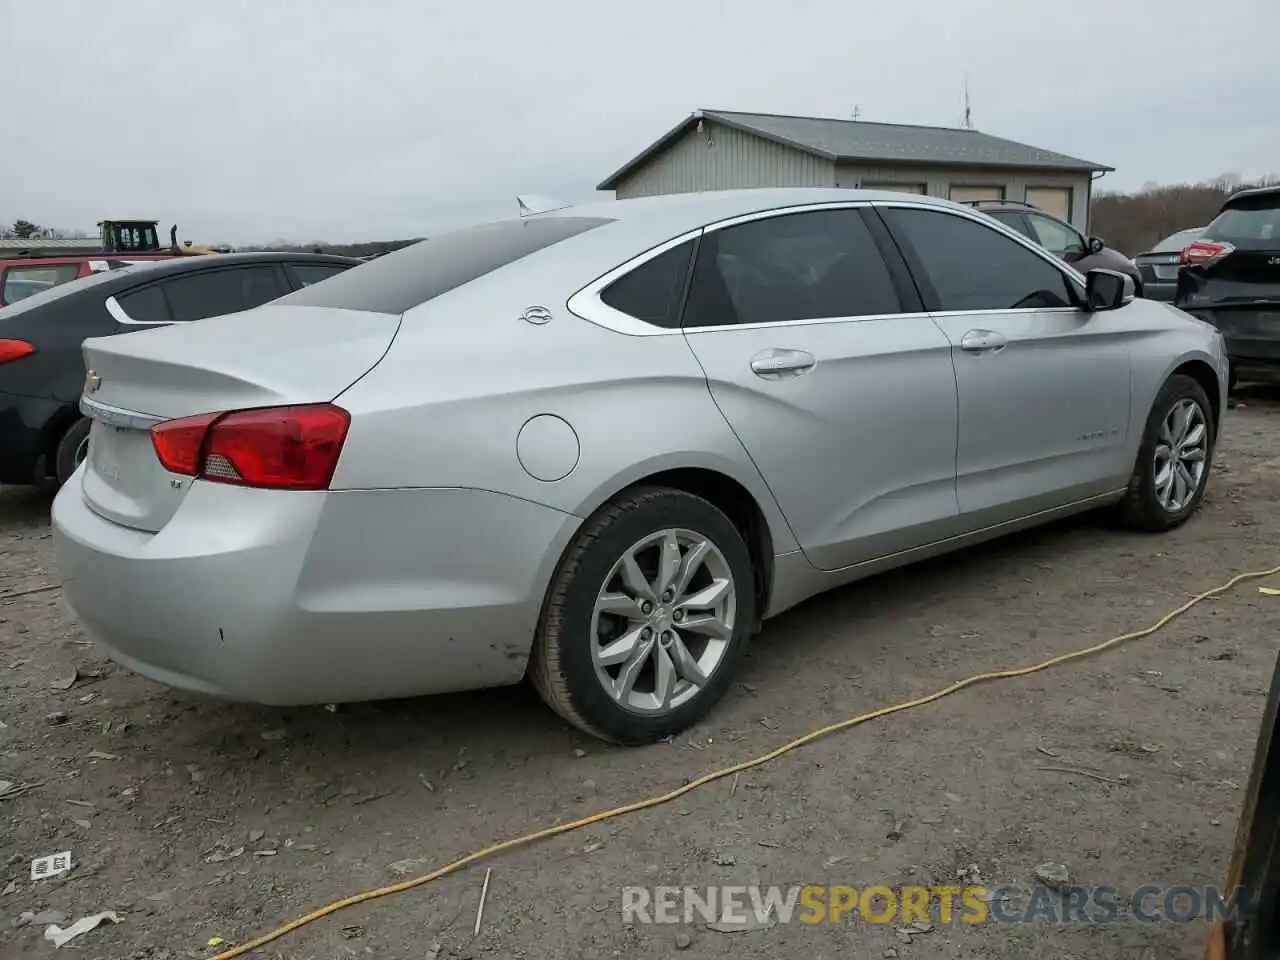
[614,120,836,200]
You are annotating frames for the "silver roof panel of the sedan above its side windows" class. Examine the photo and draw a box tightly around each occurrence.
[535,187,972,234]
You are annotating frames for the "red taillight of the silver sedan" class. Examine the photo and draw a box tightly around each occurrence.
[151,403,351,490]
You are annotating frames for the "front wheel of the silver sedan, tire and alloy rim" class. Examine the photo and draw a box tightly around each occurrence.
[1120,374,1217,532]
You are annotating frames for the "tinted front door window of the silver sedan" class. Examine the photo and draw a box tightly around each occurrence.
[883,209,1074,311]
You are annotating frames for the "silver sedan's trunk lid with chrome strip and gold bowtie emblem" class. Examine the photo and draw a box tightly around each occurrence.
[81,305,399,532]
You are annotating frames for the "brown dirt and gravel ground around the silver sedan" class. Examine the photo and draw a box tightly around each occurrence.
[0,390,1280,960]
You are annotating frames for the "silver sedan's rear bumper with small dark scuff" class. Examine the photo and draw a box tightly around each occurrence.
[52,472,580,705]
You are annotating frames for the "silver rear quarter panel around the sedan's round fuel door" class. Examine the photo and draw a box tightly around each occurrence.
[325,239,796,553]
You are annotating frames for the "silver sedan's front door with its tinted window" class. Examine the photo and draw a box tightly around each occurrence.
[881,206,1133,529]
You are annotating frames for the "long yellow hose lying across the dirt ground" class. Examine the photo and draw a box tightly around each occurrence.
[211,566,1280,960]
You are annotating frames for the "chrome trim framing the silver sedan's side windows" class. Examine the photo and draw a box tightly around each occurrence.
[576,197,1084,337]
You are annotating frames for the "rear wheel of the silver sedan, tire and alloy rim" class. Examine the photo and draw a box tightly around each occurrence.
[529,488,755,744]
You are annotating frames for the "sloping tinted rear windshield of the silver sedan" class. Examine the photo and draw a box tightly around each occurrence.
[275,216,609,314]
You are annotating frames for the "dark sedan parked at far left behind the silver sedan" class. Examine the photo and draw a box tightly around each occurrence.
[0,253,360,484]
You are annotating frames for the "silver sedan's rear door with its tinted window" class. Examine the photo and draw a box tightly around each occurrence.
[682,206,959,570]
